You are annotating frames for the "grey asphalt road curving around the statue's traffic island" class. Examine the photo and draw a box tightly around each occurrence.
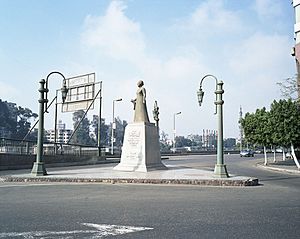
[0,155,300,239]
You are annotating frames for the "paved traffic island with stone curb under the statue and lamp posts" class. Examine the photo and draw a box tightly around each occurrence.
[0,165,259,187]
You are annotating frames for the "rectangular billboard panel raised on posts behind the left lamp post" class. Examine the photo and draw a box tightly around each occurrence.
[62,73,96,112]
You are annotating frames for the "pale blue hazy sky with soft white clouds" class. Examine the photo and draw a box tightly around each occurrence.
[0,0,296,138]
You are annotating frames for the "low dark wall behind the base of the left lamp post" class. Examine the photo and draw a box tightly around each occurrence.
[0,154,105,170]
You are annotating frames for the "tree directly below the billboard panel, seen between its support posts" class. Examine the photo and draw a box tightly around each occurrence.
[72,110,95,145]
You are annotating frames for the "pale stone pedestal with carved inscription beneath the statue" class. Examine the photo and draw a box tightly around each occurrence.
[114,122,167,172]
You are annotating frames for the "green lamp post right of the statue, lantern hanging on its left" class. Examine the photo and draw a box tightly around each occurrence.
[197,75,229,178]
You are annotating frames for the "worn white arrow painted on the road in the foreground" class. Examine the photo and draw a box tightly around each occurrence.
[0,223,153,239]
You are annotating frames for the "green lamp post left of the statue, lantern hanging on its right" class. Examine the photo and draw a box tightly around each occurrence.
[31,71,68,176]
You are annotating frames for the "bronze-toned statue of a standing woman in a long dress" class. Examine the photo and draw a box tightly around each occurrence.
[132,80,149,122]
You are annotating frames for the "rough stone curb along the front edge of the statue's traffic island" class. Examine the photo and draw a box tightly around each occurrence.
[0,176,259,187]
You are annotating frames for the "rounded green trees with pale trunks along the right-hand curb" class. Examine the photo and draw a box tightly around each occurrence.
[241,99,300,168]
